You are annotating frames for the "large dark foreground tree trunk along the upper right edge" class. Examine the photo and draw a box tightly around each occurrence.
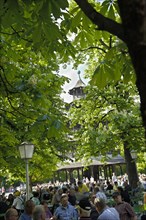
[118,0,146,137]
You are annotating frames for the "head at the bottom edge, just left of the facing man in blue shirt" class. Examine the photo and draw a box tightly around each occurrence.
[32,205,46,220]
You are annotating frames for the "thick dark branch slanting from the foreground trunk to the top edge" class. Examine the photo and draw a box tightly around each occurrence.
[74,0,125,42]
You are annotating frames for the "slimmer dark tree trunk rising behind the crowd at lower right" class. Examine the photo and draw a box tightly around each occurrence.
[124,143,139,189]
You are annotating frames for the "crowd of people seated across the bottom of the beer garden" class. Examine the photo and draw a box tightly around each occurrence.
[0,173,146,220]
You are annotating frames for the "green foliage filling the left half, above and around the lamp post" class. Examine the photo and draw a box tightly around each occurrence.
[0,0,71,181]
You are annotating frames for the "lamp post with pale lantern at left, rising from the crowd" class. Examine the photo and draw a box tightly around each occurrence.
[19,142,34,201]
